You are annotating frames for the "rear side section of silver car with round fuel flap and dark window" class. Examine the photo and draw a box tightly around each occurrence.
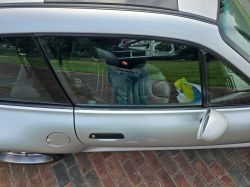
[0,35,82,153]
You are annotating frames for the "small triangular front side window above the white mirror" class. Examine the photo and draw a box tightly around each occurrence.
[206,54,250,105]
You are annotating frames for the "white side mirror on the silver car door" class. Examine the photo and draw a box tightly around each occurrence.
[197,109,229,142]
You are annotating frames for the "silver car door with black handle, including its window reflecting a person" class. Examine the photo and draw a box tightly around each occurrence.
[39,34,250,148]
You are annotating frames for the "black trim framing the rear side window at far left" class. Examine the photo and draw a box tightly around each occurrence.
[0,33,74,109]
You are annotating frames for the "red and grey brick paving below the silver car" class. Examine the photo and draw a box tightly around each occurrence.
[0,147,250,187]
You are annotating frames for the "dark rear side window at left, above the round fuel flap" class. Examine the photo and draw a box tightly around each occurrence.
[0,37,67,104]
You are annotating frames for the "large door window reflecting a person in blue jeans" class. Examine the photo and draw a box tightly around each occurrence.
[39,36,201,105]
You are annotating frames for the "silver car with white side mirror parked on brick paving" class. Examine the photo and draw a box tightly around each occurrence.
[0,0,250,164]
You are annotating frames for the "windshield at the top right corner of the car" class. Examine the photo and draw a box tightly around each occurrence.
[219,0,250,62]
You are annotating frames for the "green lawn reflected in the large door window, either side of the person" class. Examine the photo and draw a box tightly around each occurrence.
[51,59,200,84]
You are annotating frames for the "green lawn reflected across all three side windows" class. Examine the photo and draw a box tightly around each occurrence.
[0,56,230,87]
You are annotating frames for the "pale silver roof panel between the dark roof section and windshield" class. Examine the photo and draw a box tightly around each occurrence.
[178,0,218,20]
